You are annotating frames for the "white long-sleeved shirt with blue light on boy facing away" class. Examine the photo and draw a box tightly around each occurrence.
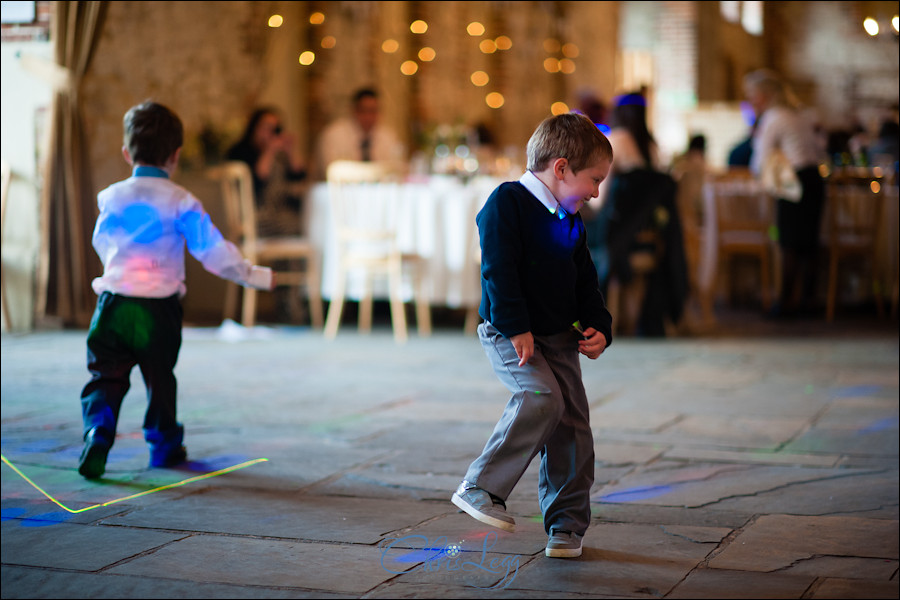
[92,166,272,298]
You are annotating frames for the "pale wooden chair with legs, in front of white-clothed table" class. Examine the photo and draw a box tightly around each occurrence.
[325,160,431,343]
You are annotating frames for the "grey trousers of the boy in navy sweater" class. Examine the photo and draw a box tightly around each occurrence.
[466,322,594,535]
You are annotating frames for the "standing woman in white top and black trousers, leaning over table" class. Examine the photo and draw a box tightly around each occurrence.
[744,69,825,317]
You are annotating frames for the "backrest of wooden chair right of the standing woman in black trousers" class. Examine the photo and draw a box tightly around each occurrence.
[825,172,889,250]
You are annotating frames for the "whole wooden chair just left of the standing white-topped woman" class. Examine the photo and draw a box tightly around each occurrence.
[703,169,776,310]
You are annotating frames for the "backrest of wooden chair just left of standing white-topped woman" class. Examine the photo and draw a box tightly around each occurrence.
[705,170,774,240]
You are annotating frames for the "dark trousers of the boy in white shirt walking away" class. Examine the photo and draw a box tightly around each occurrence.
[81,292,184,460]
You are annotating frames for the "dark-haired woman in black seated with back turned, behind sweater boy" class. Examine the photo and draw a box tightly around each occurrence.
[587,94,688,336]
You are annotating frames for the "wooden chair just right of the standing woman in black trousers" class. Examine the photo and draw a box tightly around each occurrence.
[825,175,886,323]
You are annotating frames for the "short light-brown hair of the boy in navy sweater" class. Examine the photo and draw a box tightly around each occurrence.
[526,113,613,173]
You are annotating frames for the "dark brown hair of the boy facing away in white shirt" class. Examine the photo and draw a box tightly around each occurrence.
[122,100,184,167]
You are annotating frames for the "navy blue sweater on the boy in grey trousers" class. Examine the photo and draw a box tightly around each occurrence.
[475,181,612,344]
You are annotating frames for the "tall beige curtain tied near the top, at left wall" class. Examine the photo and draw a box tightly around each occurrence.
[35,2,107,327]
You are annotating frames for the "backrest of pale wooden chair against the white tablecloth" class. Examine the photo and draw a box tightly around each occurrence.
[326,160,400,257]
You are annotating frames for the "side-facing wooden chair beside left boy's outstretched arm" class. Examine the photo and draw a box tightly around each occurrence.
[207,161,322,328]
